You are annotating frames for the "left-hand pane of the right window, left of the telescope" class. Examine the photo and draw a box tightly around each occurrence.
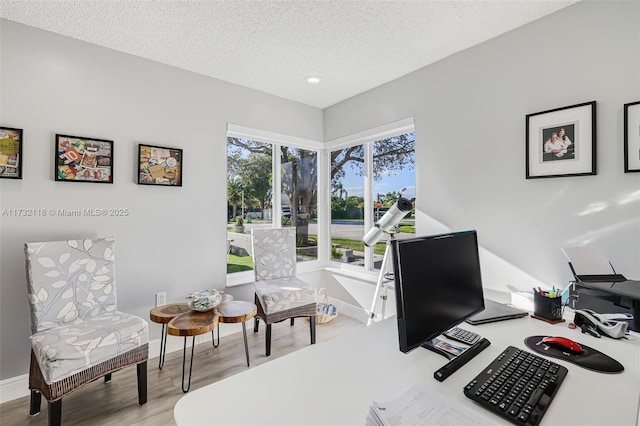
[330,145,364,266]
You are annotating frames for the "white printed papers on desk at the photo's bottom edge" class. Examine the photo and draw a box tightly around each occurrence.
[366,385,495,426]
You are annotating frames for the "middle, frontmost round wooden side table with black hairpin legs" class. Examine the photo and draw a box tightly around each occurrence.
[167,308,220,393]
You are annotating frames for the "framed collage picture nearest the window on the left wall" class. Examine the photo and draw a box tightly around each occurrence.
[138,144,182,186]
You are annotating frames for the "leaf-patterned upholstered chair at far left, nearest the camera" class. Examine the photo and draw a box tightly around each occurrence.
[25,238,149,425]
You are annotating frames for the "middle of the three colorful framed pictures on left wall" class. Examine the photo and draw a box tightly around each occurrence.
[55,135,113,183]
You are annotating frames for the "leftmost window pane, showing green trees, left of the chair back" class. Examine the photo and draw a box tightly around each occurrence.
[227,138,273,273]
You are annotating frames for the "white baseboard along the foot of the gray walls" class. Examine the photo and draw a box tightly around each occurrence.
[0,304,368,404]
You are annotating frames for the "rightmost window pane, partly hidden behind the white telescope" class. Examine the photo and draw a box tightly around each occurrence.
[371,132,416,269]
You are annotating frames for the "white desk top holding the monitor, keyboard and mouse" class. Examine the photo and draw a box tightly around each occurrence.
[174,313,640,426]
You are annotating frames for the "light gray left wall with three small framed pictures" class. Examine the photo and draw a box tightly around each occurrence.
[0,20,323,379]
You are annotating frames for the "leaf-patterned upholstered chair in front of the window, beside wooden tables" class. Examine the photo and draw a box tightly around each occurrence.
[251,228,316,356]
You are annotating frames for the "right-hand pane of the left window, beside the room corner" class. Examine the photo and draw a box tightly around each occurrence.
[280,146,318,262]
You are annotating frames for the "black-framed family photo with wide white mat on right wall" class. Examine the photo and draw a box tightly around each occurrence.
[525,101,596,179]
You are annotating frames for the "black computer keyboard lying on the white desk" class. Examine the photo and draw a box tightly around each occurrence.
[464,346,568,425]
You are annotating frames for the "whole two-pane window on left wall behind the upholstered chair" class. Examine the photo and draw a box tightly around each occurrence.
[227,132,318,274]
